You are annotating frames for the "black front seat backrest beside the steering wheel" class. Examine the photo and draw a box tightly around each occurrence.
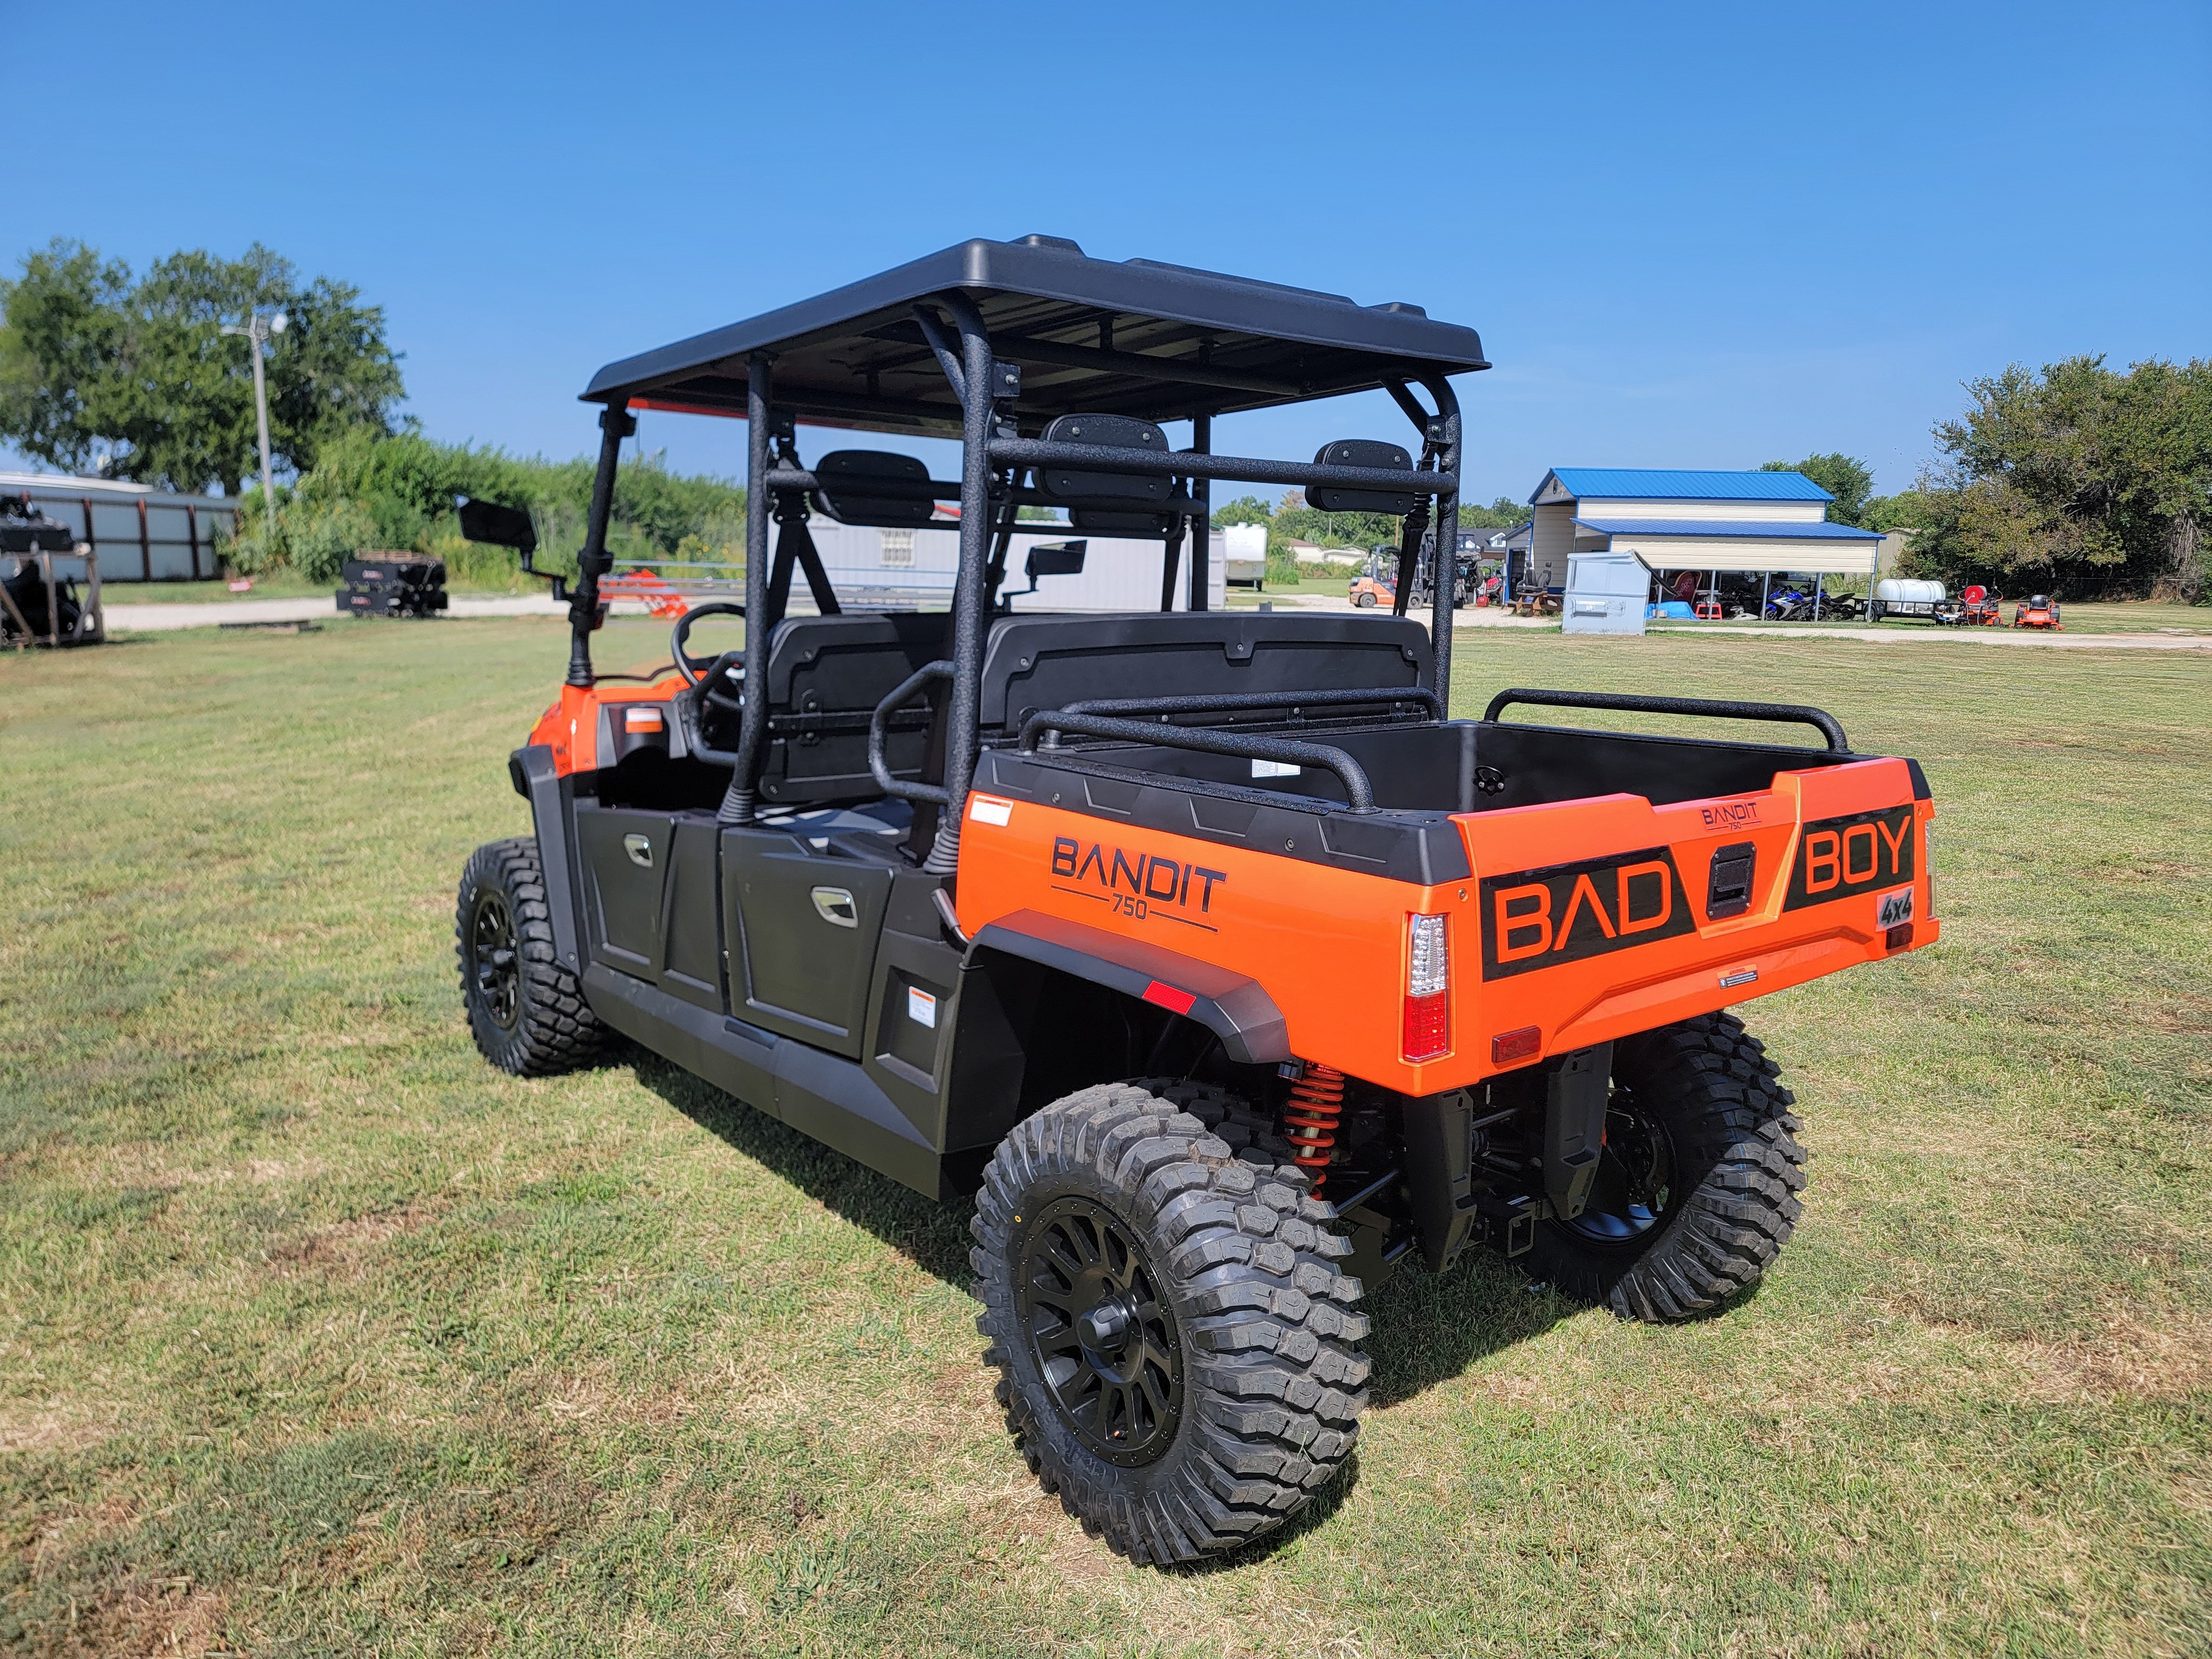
[752,611,951,807]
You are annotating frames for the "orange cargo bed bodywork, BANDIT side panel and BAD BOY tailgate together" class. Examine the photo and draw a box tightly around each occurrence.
[958,761,1940,1093]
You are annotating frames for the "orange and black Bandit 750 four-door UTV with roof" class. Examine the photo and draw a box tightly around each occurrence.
[458,237,1938,1564]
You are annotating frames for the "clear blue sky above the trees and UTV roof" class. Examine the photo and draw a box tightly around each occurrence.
[0,0,2212,500]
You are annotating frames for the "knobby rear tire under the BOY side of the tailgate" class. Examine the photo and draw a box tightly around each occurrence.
[1531,1013,1807,1323]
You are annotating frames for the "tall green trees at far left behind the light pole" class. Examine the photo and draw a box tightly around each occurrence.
[0,239,405,493]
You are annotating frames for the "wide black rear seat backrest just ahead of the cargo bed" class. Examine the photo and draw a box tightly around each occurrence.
[982,611,1431,741]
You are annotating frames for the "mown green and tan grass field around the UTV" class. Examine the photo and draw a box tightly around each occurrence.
[0,622,2212,1657]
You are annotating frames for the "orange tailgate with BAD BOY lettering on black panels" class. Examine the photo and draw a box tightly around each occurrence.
[1453,759,1940,1068]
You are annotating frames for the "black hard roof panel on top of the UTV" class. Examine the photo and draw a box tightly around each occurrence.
[584,237,1489,436]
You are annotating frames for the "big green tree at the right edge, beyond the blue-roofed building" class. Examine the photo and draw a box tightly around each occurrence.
[1913,356,2212,599]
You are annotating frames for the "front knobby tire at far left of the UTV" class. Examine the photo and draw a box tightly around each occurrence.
[453,836,613,1077]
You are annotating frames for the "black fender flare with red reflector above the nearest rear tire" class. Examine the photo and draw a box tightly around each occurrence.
[964,909,1292,1066]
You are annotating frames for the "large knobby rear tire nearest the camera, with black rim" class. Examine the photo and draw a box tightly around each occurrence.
[969,1084,1367,1564]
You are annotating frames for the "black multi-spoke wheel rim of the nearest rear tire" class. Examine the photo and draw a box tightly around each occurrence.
[1020,1197,1183,1467]
